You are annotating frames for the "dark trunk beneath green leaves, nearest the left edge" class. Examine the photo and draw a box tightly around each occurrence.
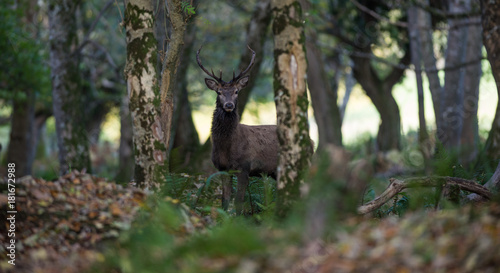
[7,90,36,177]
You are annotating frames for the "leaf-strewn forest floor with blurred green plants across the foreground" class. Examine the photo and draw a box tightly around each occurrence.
[0,172,500,272]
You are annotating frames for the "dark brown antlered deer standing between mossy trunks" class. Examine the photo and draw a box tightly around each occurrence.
[196,46,279,215]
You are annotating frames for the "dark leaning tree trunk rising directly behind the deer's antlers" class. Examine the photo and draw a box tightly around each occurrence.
[238,0,271,118]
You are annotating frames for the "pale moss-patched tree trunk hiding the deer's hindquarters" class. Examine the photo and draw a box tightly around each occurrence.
[271,0,313,217]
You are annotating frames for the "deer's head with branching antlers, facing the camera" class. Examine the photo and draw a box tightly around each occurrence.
[196,46,255,112]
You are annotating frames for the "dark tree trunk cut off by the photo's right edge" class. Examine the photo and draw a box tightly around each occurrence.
[481,0,500,160]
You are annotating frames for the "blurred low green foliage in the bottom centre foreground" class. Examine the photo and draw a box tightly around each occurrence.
[93,197,266,273]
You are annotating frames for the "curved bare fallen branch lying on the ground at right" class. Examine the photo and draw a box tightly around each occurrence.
[358,176,491,214]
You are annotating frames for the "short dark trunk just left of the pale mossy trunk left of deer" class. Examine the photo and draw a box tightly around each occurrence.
[115,96,135,183]
